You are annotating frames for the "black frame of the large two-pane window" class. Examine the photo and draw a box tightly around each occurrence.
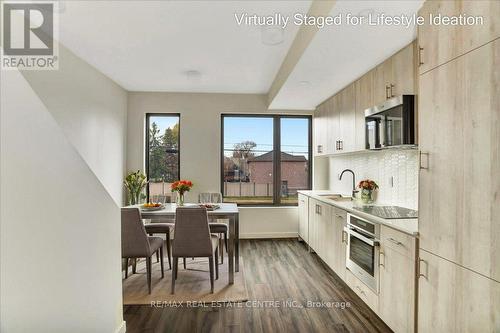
[220,113,313,207]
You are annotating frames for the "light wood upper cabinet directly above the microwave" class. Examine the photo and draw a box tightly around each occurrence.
[369,42,416,107]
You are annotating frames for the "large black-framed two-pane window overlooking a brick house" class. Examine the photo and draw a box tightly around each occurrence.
[221,115,311,205]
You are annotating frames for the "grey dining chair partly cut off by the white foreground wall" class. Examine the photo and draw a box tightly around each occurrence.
[121,208,165,294]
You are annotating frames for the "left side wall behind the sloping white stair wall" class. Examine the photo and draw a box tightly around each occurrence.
[22,44,127,206]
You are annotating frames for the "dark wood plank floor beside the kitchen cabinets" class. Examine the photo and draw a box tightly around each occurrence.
[124,239,391,333]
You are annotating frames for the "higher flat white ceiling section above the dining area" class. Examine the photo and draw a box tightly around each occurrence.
[60,1,311,93]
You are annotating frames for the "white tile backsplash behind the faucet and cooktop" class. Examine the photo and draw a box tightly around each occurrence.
[329,150,419,209]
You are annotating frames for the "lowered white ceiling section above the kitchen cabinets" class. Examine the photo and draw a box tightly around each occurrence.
[270,0,424,109]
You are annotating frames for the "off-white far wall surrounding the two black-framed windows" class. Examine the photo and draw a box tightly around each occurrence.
[127,92,310,238]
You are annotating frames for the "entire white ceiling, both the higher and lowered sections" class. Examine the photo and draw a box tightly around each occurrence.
[60,0,423,109]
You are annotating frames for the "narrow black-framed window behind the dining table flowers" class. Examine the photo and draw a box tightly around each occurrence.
[146,114,180,201]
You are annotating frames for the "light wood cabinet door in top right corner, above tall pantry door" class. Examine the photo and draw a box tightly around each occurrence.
[418,0,500,74]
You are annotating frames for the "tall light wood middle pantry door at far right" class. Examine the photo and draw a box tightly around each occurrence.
[419,39,500,281]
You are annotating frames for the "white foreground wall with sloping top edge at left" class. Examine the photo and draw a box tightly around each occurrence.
[0,70,123,333]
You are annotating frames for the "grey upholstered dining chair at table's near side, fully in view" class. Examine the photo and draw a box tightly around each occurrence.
[171,207,219,294]
